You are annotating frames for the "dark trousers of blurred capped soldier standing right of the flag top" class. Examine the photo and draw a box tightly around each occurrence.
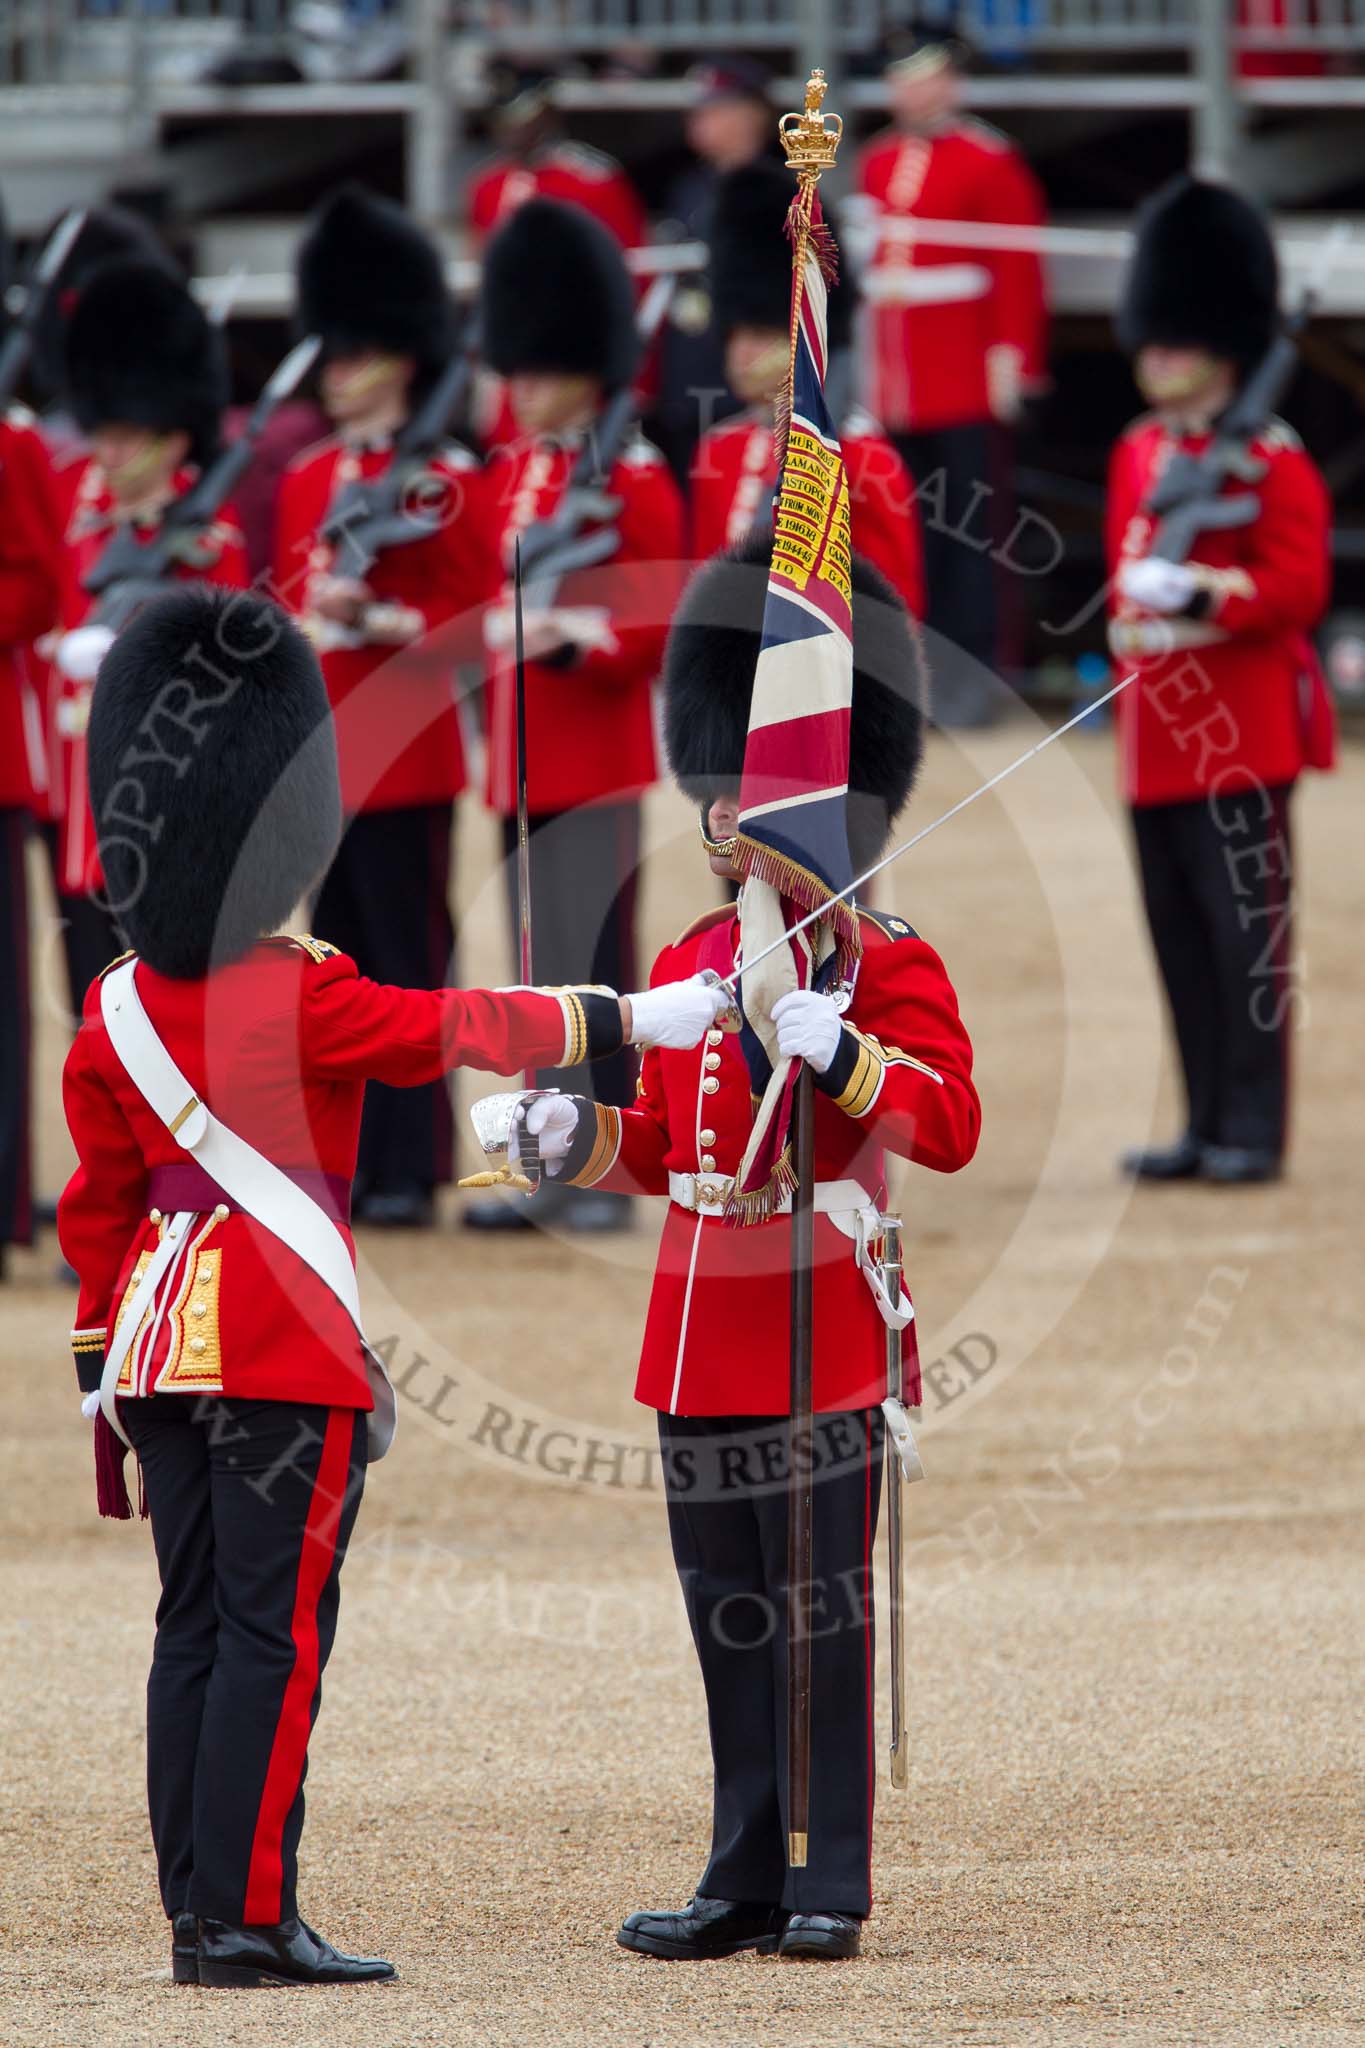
[892,420,999,725]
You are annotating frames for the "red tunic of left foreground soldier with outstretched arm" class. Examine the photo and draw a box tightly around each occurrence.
[57,938,620,1407]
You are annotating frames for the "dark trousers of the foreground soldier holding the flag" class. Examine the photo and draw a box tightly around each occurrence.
[659,1409,884,1917]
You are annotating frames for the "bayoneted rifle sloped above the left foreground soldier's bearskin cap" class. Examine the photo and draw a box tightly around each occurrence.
[82,334,321,633]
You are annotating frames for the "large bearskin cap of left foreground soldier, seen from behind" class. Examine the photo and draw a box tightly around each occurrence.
[90,584,342,981]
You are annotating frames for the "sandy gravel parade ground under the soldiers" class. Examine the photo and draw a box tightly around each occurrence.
[0,731,1365,2048]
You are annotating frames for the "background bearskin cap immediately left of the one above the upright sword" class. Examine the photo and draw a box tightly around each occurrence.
[297,184,454,373]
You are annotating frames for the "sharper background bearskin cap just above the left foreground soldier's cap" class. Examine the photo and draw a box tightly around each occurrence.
[65,256,227,465]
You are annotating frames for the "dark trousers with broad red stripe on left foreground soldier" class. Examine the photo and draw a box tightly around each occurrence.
[119,1395,366,1925]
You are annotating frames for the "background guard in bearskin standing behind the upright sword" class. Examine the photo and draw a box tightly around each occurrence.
[465,199,684,1229]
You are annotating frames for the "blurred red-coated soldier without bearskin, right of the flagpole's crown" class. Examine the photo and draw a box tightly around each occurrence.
[855,33,1046,725]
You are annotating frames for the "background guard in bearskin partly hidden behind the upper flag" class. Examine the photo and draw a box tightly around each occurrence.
[690,162,925,618]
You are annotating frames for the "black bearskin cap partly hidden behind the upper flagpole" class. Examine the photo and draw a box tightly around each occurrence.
[710,162,857,354]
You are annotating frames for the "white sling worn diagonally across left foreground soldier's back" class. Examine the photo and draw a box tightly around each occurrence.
[100,961,397,1464]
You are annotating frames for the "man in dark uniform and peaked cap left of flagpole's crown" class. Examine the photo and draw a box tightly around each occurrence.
[655,57,776,479]
